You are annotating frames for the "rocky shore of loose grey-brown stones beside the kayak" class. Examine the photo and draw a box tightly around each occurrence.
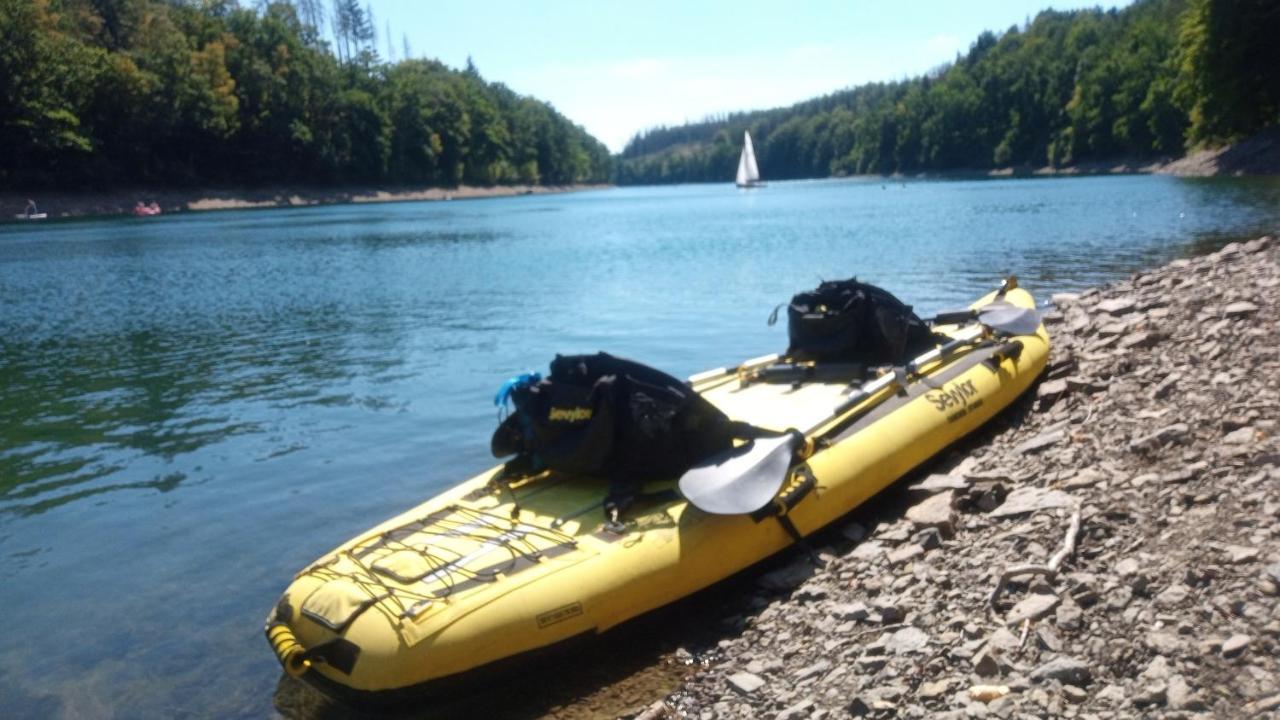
[632,237,1280,720]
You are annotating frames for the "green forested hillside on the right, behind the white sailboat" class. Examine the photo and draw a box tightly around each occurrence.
[618,0,1280,183]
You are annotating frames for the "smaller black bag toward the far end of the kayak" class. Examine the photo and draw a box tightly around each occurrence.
[787,278,937,365]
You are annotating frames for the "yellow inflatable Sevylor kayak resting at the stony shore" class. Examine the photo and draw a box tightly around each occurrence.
[266,281,1048,705]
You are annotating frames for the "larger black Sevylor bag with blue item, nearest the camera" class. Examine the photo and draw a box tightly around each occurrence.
[492,352,751,496]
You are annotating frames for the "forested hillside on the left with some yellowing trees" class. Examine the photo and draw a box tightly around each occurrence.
[0,0,612,190]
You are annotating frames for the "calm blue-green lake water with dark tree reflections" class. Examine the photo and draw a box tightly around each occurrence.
[0,176,1280,717]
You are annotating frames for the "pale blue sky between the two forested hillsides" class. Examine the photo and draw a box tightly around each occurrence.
[371,0,1128,151]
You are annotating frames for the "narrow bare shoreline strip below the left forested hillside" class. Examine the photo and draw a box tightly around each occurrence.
[0,184,613,222]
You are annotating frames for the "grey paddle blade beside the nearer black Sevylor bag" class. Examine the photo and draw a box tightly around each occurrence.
[680,434,800,515]
